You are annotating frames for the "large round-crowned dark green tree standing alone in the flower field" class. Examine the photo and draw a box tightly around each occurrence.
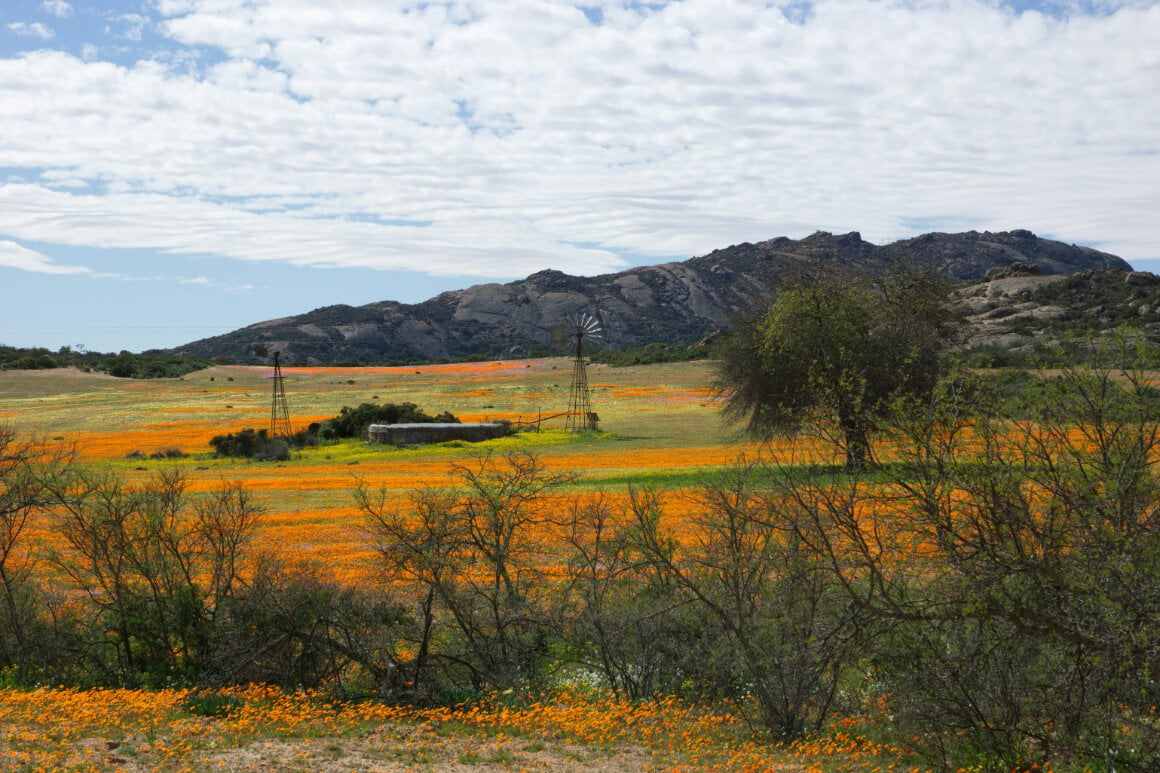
[717,263,958,469]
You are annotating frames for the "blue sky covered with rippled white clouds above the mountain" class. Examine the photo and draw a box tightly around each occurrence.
[0,0,1160,352]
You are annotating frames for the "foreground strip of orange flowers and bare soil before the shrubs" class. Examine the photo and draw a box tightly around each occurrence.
[0,686,904,772]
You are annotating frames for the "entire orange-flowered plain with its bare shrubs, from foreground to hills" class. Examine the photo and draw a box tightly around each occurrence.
[0,359,1160,773]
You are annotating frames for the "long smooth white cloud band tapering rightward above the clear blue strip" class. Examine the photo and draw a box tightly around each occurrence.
[0,183,622,277]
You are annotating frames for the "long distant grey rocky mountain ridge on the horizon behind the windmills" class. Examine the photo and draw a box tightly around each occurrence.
[171,231,1131,364]
